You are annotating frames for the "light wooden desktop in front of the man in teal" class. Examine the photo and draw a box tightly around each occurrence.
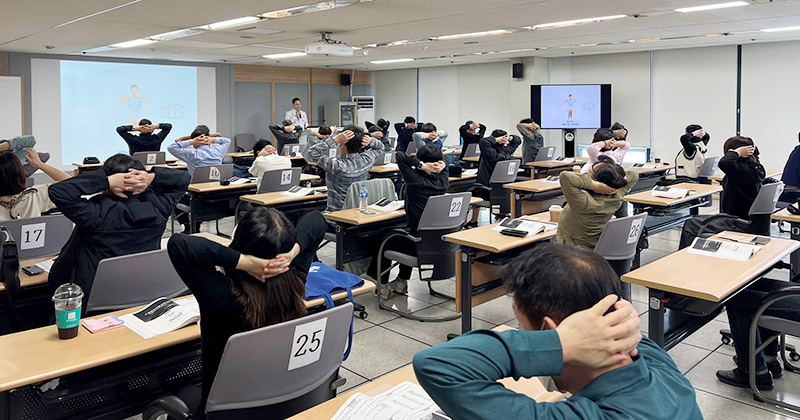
[289,325,565,420]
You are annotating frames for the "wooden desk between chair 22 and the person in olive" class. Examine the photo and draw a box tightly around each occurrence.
[442,212,556,332]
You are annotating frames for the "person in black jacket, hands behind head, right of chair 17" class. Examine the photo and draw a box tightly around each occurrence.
[48,154,191,308]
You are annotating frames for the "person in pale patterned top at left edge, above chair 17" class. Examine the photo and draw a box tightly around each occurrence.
[0,147,70,221]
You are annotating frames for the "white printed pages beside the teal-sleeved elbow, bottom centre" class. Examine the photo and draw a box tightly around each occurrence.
[331,382,439,420]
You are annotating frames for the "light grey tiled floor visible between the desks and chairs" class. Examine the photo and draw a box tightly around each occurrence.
[128,200,800,420]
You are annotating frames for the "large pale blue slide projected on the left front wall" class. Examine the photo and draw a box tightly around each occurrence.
[61,60,197,165]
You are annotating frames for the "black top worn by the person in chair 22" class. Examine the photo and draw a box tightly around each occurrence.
[395,152,450,231]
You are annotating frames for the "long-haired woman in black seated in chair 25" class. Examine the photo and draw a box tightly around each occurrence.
[167,207,327,419]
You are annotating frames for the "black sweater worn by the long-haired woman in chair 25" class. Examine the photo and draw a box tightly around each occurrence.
[167,212,326,418]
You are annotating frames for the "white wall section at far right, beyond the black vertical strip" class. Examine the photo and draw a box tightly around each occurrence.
[741,42,800,168]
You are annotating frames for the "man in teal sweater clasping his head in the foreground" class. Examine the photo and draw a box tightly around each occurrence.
[413,244,703,420]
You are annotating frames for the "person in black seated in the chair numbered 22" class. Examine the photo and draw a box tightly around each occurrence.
[367,145,450,299]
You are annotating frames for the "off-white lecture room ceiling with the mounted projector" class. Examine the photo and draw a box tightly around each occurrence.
[0,0,800,70]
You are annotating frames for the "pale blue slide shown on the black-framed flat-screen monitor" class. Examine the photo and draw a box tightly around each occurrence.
[541,85,600,128]
